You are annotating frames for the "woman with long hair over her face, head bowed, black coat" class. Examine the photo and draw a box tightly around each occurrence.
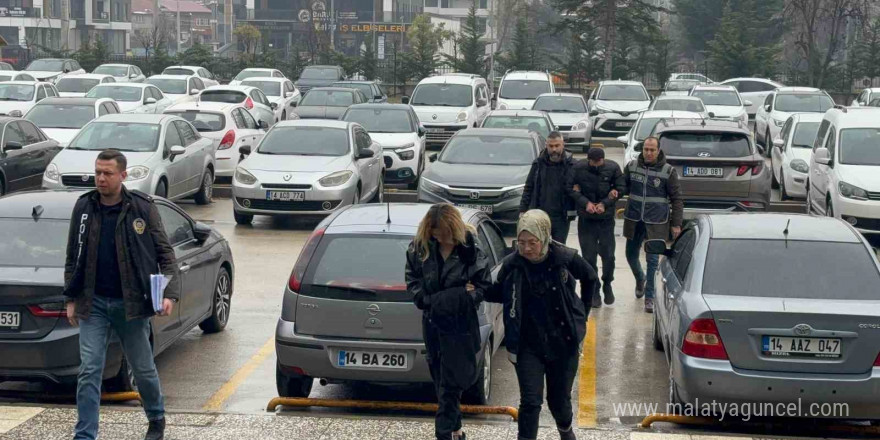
[406,203,492,440]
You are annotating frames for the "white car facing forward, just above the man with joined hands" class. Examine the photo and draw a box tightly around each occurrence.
[587,81,651,139]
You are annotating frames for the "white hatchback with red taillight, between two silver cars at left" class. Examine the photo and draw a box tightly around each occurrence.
[165,102,266,177]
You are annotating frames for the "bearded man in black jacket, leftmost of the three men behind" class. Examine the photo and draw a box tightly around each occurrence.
[519,131,574,244]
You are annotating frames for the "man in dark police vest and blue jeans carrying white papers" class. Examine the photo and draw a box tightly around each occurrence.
[64,150,180,440]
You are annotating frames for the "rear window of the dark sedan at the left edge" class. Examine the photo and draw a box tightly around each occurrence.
[0,217,68,267]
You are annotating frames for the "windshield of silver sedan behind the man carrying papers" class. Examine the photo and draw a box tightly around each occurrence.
[67,121,159,152]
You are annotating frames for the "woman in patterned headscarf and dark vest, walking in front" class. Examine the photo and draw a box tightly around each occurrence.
[485,209,598,440]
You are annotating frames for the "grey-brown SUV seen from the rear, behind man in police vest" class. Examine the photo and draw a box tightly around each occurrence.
[656,119,771,219]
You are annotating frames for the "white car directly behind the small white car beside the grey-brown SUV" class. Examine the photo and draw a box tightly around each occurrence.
[755,87,834,152]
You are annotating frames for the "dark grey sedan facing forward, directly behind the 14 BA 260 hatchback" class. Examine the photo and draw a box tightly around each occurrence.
[418,128,544,225]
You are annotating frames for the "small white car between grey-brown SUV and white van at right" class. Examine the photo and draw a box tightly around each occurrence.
[770,113,823,200]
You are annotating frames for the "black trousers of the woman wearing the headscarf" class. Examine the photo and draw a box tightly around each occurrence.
[516,347,580,440]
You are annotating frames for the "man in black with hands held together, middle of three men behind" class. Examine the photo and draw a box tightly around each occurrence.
[567,148,626,307]
